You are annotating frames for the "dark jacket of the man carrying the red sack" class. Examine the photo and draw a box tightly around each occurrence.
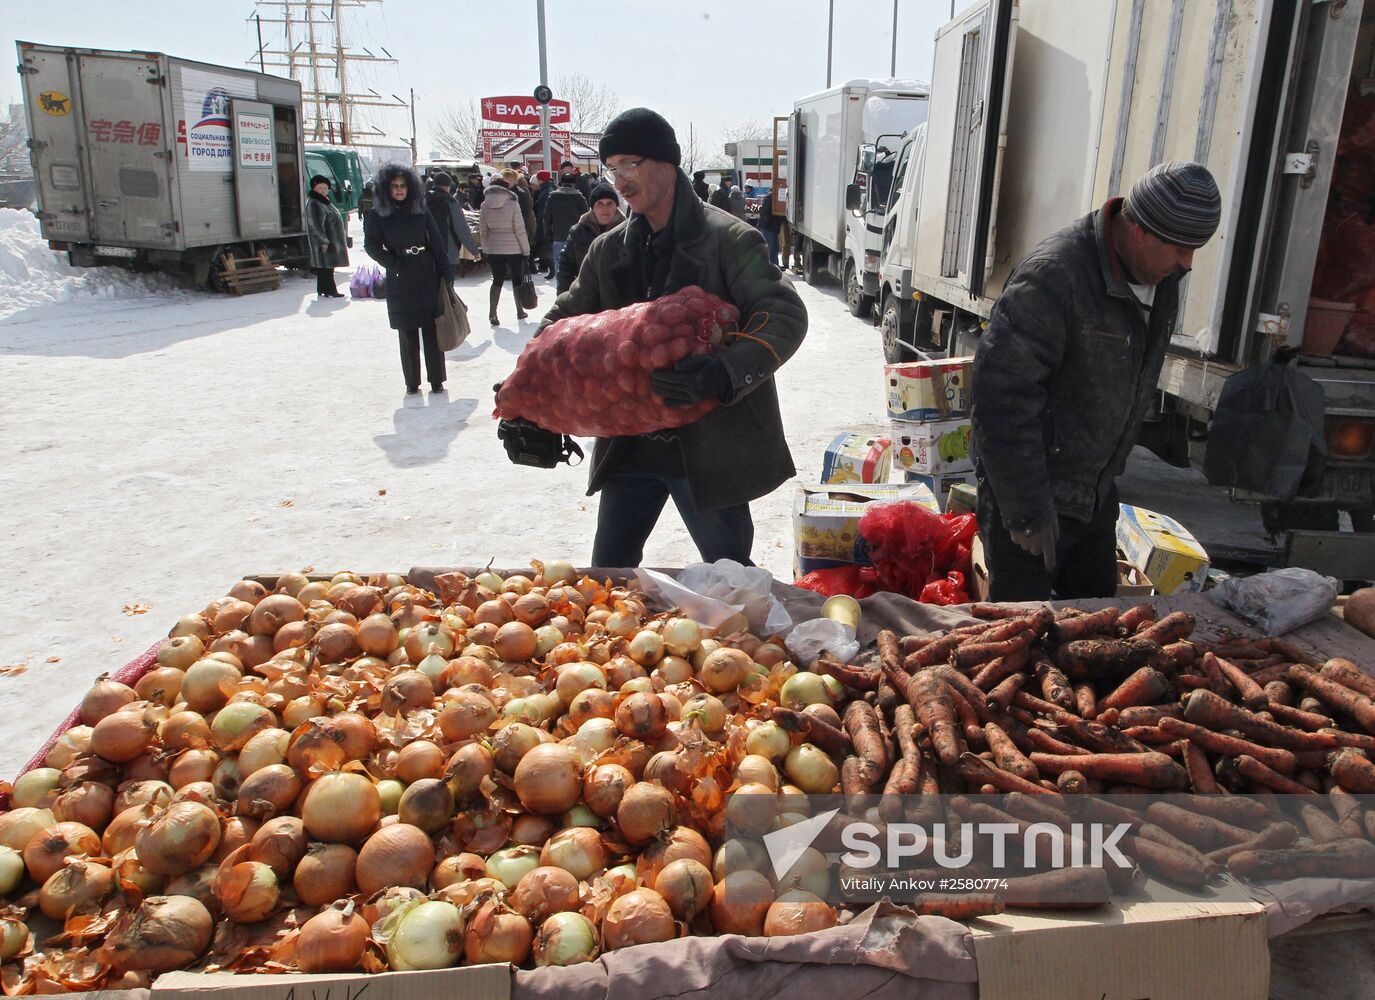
[540,171,807,510]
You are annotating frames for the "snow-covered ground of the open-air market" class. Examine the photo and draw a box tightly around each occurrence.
[0,212,887,777]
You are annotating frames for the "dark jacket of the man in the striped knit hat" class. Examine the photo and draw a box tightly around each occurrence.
[974,198,1180,530]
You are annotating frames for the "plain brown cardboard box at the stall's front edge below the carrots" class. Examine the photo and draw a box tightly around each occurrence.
[969,900,1271,1000]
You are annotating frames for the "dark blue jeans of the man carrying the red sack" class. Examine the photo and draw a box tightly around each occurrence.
[593,472,755,567]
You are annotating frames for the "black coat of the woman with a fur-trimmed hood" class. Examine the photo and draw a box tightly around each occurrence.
[363,164,448,330]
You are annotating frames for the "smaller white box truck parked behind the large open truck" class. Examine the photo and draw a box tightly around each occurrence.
[788,80,930,316]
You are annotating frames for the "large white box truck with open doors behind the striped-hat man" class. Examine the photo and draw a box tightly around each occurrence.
[879,0,1375,579]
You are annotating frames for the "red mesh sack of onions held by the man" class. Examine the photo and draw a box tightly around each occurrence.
[496,285,740,437]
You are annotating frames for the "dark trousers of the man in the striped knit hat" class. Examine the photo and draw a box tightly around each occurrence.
[979,483,1118,602]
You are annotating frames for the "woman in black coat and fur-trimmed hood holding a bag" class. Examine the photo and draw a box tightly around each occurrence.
[363,164,448,396]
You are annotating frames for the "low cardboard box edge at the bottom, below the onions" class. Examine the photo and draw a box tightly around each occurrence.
[151,964,513,1000]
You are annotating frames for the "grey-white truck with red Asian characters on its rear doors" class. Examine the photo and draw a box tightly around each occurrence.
[17,41,308,287]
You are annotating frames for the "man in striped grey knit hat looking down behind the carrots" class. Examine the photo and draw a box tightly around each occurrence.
[972,161,1222,601]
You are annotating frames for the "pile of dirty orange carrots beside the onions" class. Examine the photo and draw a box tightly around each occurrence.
[813,602,1375,916]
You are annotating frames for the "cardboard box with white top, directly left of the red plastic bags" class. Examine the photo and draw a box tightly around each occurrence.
[792,483,941,576]
